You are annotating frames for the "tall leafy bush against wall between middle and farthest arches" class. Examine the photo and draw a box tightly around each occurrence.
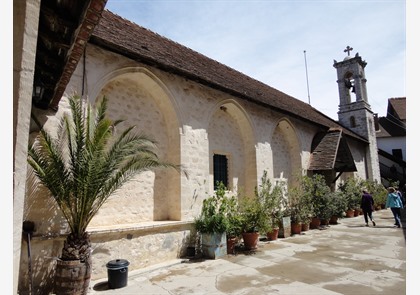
[255,171,286,228]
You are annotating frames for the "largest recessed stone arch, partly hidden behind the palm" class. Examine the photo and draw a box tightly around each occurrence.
[90,67,181,224]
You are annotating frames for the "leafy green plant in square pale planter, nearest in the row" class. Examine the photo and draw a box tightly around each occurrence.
[194,182,234,259]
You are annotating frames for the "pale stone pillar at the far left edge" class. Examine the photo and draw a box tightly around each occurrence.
[13,0,41,294]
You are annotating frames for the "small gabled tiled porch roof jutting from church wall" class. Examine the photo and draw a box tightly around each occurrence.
[308,129,357,172]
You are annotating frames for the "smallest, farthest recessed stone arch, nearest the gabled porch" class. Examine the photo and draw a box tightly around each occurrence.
[271,119,302,186]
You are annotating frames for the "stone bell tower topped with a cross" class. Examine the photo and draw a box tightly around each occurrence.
[334,46,381,183]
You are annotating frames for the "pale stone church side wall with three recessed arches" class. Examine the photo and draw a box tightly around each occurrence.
[22,45,364,292]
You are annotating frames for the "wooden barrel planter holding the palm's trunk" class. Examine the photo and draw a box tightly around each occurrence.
[54,259,91,295]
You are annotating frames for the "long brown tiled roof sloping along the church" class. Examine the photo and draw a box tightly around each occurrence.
[89,10,366,142]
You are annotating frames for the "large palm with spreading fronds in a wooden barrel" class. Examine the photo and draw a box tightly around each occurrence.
[28,95,179,294]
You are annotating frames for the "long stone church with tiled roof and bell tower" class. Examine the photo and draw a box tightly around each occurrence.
[15,3,380,290]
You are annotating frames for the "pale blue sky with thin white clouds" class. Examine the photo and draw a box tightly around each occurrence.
[105,0,406,120]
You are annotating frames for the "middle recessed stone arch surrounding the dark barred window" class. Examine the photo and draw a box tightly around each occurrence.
[207,100,256,199]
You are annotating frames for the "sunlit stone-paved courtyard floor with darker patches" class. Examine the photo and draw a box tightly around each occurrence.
[89,210,406,295]
